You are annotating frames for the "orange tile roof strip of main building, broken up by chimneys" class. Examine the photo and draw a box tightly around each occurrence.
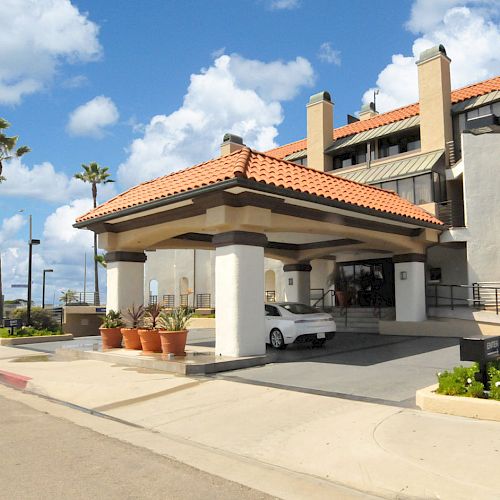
[266,76,500,158]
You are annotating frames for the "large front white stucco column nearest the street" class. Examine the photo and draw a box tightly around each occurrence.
[213,231,267,357]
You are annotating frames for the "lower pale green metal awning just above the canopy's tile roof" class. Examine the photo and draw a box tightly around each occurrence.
[332,149,444,184]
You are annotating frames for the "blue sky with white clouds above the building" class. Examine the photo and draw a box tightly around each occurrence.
[0,0,500,299]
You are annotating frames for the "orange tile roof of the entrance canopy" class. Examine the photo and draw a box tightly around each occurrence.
[77,147,442,225]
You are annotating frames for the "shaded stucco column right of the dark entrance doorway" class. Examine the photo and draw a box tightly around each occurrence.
[393,253,427,321]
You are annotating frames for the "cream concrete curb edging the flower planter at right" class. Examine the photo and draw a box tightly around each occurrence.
[416,384,500,422]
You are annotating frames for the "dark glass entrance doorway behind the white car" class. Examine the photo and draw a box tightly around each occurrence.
[335,259,394,307]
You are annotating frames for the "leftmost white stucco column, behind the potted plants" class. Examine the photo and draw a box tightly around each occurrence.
[105,252,146,311]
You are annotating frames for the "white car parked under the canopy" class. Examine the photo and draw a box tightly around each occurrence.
[265,302,337,349]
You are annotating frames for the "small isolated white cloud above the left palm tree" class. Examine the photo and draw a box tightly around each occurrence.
[67,95,120,139]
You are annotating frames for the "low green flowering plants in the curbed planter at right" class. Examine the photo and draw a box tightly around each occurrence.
[436,361,500,400]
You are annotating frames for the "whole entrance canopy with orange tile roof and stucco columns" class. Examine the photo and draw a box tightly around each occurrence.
[75,147,444,356]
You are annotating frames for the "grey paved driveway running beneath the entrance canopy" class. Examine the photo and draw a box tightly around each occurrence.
[15,329,468,407]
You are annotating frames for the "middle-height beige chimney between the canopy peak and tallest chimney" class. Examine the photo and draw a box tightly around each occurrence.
[307,92,333,172]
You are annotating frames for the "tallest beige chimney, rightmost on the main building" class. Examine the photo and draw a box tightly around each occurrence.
[417,45,453,164]
